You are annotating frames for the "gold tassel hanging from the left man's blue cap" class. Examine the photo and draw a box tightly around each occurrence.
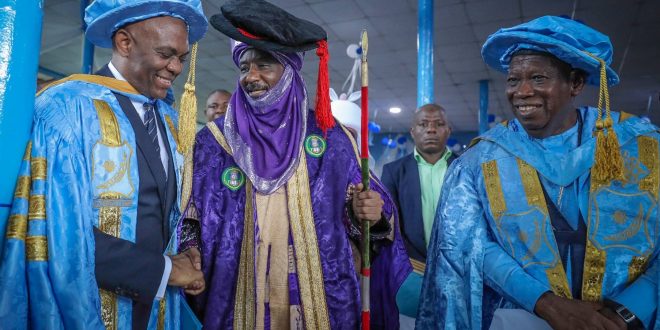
[177,43,197,156]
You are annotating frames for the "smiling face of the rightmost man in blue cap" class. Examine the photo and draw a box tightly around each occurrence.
[506,54,584,138]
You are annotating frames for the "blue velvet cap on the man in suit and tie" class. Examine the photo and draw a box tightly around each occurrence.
[85,0,208,48]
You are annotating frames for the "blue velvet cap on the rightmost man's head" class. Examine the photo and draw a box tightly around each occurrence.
[481,16,619,86]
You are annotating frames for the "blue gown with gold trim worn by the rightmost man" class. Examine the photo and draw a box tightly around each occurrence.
[417,108,660,329]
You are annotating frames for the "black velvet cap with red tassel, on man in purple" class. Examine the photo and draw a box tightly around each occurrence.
[210,0,335,132]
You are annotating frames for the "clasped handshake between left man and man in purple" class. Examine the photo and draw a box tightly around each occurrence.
[167,248,206,296]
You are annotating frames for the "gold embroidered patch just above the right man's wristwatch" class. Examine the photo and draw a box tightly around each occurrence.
[582,239,607,302]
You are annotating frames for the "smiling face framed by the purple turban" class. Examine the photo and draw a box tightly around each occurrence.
[238,48,284,99]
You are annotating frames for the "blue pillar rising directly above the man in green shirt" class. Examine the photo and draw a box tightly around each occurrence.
[417,0,434,108]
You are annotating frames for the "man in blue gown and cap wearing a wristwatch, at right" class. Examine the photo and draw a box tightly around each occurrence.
[417,16,660,329]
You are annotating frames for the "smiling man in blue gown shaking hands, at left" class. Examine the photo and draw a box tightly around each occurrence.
[0,0,208,329]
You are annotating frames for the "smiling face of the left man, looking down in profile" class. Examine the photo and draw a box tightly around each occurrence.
[113,16,188,99]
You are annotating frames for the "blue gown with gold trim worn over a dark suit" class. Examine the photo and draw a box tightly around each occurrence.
[0,75,183,329]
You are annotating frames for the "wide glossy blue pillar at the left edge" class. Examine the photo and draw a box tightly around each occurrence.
[0,0,43,235]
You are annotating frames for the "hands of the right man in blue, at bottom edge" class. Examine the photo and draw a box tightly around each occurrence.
[534,293,625,330]
